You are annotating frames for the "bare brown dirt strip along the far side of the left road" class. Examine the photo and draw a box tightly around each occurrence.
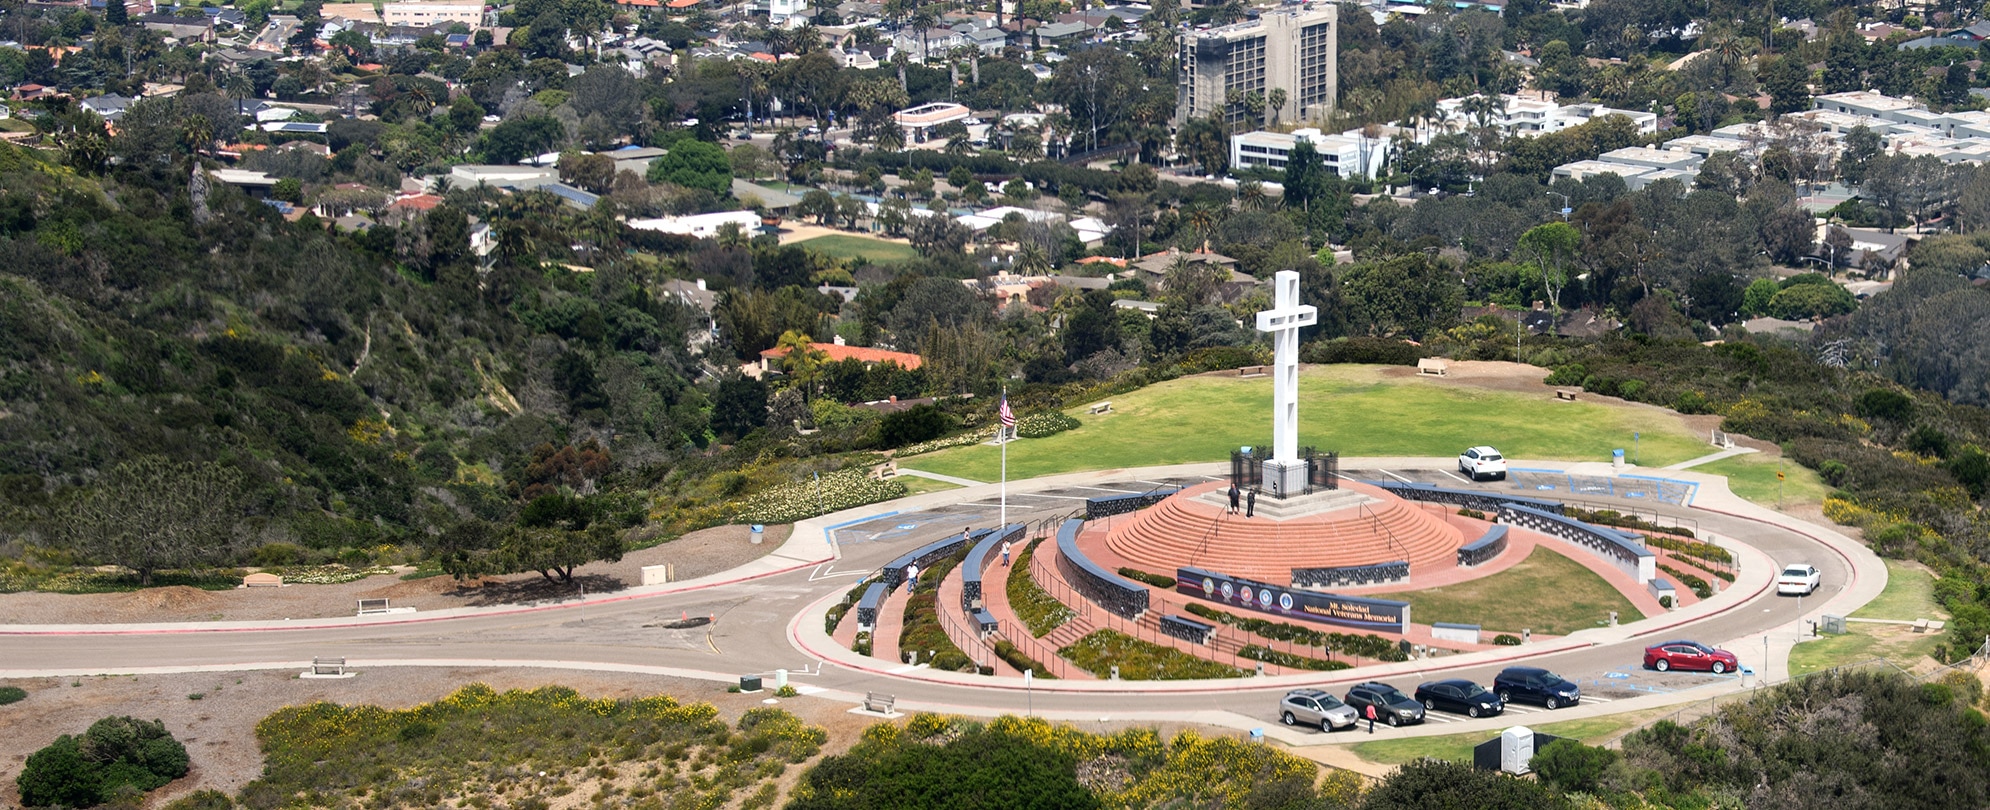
[0,525,790,625]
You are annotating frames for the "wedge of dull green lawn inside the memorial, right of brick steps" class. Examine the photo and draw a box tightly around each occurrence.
[1383,545,1642,635]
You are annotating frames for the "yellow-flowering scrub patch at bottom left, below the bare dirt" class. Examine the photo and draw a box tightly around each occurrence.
[239,683,828,808]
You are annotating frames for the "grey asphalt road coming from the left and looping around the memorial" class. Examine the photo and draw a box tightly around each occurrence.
[0,470,1851,736]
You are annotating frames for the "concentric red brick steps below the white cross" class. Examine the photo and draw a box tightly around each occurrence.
[1106,496,1465,583]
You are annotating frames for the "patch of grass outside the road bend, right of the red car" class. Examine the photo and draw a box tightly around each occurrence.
[1789,559,1948,675]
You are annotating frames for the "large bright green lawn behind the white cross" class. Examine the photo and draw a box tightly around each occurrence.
[909,366,1711,482]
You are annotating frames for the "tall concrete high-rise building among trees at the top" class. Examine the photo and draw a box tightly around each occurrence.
[1174,2,1339,129]
